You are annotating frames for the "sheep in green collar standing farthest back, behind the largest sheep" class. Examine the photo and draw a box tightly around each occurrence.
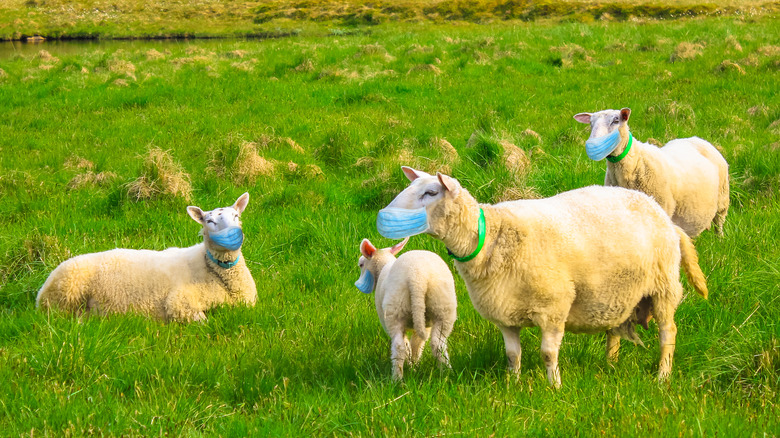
[574,108,729,237]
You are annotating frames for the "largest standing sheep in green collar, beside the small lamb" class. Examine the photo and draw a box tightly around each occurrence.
[377,167,708,387]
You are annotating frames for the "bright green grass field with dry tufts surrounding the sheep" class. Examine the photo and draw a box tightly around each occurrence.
[0,15,780,437]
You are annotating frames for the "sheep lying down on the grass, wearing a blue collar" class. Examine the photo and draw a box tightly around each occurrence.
[36,193,257,322]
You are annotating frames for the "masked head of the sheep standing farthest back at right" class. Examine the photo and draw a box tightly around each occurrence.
[574,108,631,161]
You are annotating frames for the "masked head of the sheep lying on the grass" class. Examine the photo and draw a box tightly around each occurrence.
[187,193,249,251]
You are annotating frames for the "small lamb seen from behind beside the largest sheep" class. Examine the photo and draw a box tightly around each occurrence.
[355,239,457,381]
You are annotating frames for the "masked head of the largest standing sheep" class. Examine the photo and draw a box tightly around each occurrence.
[376,166,476,239]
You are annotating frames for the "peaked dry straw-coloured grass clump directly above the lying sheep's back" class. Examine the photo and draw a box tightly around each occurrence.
[127,147,192,201]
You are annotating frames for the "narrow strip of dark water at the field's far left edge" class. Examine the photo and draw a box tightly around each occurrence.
[0,38,253,60]
